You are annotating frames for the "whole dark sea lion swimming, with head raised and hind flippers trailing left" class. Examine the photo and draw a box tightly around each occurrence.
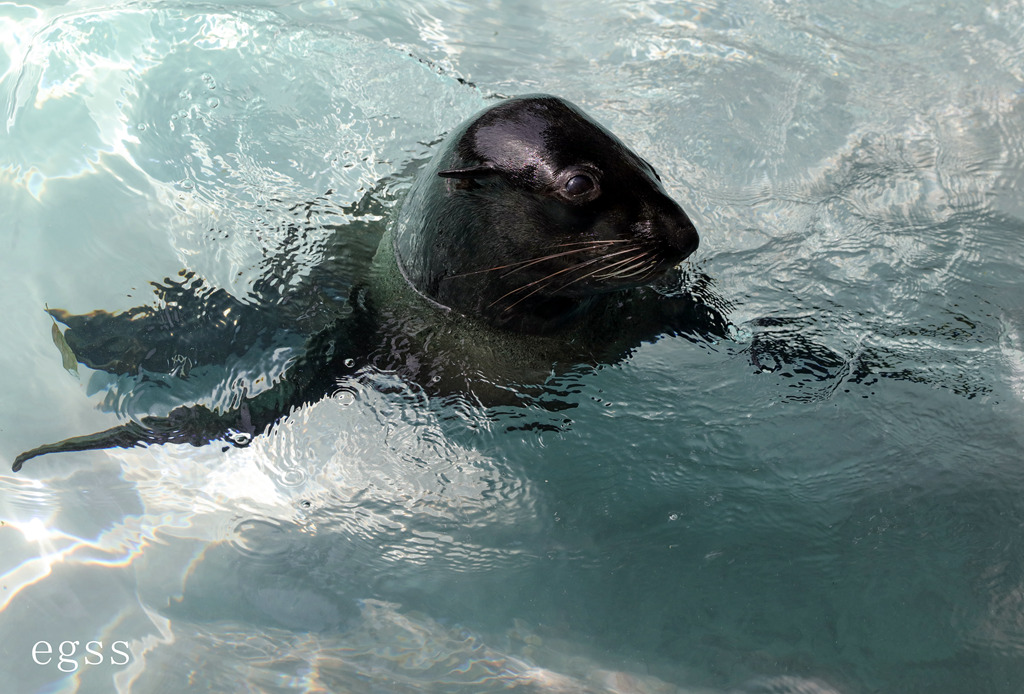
[13,95,726,471]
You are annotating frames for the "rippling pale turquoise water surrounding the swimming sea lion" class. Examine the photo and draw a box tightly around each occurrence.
[0,0,1024,694]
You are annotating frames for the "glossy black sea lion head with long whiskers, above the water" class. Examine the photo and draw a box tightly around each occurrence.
[394,95,698,333]
